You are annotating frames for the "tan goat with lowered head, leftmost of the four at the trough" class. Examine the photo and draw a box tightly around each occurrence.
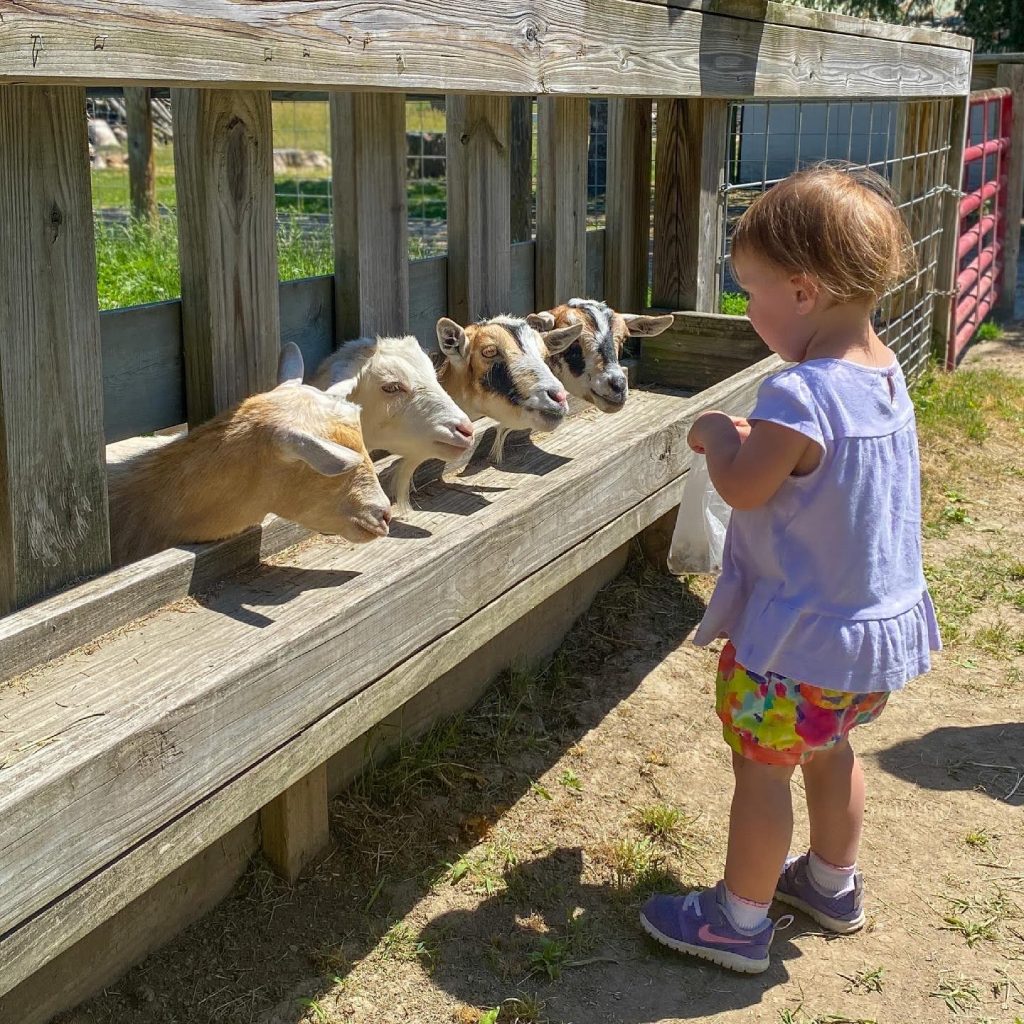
[106,344,391,565]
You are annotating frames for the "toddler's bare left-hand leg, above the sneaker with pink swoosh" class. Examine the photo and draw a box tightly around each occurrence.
[725,753,793,903]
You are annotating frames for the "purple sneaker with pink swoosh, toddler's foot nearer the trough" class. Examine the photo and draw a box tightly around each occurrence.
[640,882,792,974]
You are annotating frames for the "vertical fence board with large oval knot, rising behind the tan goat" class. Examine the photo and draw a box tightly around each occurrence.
[172,89,281,426]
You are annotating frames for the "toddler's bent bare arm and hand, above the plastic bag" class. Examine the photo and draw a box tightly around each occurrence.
[687,412,821,509]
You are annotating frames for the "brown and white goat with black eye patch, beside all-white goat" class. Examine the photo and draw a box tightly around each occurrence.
[437,316,583,462]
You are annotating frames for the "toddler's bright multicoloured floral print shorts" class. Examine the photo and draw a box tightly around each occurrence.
[715,642,889,765]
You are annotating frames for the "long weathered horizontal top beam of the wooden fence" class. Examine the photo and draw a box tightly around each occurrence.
[0,0,971,98]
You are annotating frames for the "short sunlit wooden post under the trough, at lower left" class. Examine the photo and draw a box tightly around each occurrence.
[260,763,331,882]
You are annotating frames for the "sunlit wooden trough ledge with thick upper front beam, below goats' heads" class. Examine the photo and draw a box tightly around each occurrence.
[0,364,770,954]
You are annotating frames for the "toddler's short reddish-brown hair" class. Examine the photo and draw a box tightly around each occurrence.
[732,164,915,307]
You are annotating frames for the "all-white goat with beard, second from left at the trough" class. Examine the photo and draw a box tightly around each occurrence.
[310,336,473,511]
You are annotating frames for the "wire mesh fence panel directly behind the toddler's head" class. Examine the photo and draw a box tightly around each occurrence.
[719,99,952,377]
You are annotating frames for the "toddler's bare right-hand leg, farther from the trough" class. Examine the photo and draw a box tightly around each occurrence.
[803,739,864,865]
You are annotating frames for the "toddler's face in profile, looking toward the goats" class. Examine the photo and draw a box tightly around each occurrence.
[732,253,819,362]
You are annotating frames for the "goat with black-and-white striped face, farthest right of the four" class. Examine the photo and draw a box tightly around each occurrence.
[526,299,673,413]
